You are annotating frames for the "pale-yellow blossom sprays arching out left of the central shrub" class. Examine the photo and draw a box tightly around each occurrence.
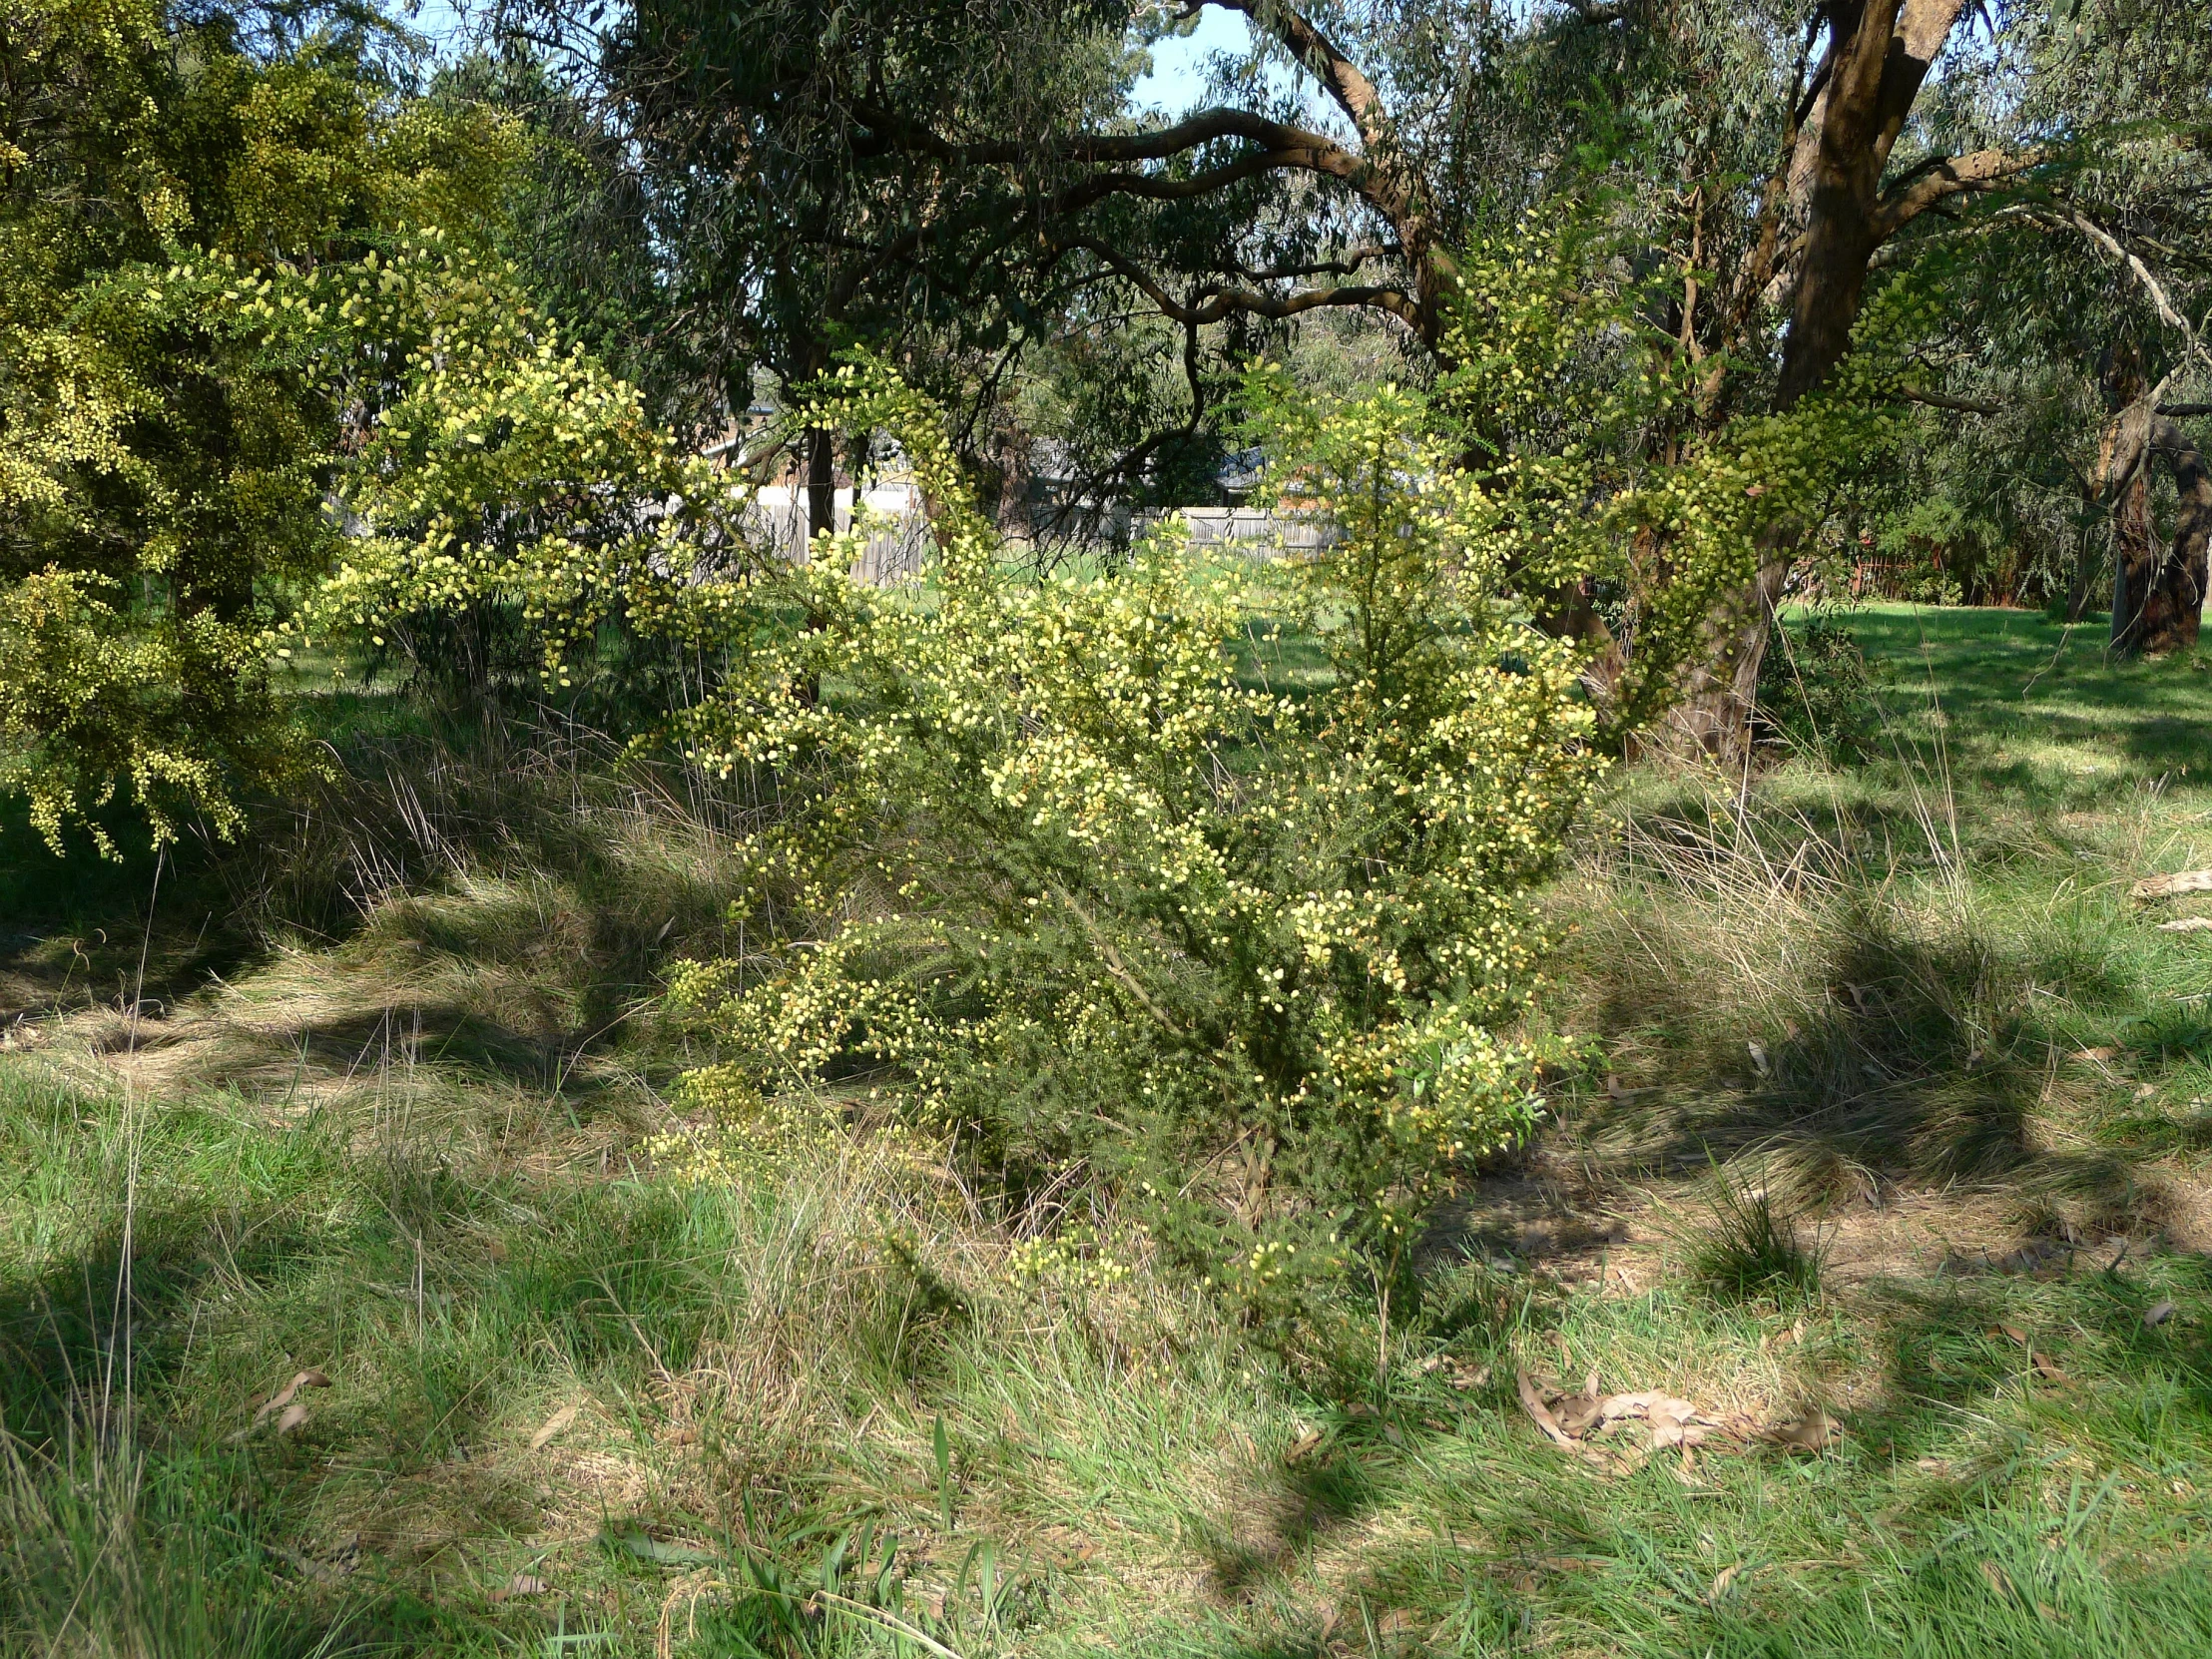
[298,237,750,704]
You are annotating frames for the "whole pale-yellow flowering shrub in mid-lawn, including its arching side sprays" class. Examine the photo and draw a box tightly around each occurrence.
[280,208,1898,1283]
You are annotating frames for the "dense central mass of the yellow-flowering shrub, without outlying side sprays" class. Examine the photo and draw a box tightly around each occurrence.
[654,365,1599,1274]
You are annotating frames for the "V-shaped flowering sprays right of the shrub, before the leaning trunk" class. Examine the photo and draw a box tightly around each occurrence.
[1435,199,1939,739]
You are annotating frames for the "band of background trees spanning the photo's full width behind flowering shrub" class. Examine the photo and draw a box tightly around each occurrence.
[0,0,2212,857]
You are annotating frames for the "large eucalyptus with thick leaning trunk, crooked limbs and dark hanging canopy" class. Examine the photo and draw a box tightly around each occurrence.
[513,0,2201,755]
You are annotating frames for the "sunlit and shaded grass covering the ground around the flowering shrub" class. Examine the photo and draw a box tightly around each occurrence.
[0,606,2212,1659]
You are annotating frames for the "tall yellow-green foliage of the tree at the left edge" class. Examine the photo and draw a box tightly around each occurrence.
[0,0,509,845]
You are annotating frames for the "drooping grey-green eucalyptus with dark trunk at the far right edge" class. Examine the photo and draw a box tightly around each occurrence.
[1885,0,2212,651]
